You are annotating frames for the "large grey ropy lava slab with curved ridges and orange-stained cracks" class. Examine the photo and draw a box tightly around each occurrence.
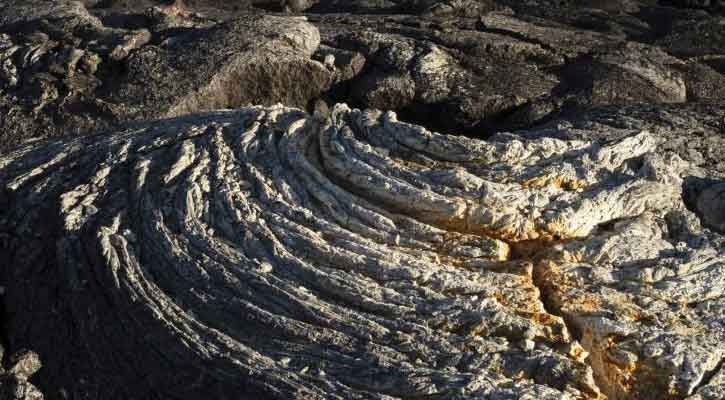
[0,105,725,399]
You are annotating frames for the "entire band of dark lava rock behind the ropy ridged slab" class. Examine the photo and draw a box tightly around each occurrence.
[0,0,725,152]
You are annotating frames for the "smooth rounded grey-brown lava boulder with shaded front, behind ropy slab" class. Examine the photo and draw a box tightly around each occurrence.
[102,17,331,119]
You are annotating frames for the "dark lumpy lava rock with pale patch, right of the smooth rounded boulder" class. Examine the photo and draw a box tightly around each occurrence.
[325,19,558,133]
